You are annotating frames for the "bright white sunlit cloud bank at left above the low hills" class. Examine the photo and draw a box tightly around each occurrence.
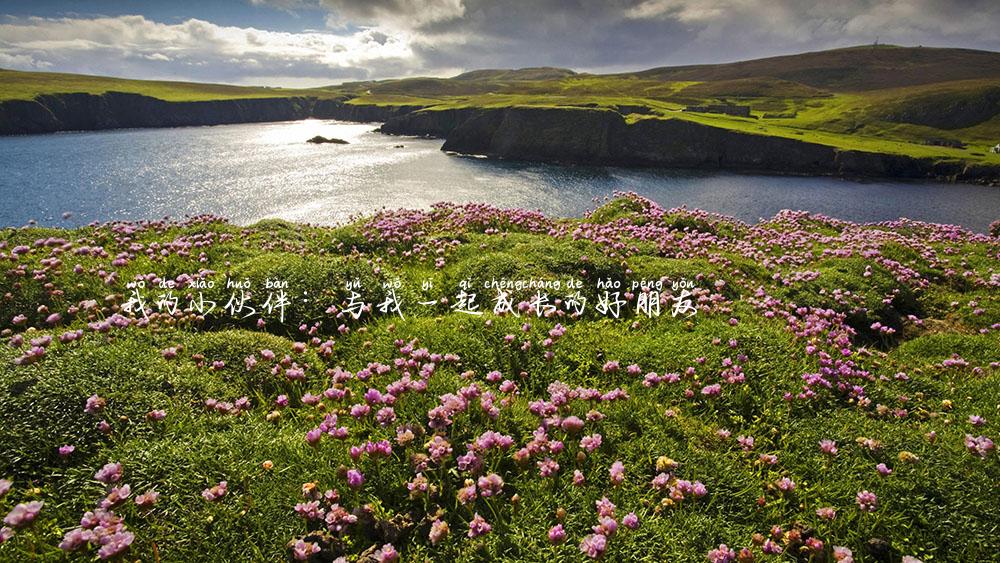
[0,15,415,84]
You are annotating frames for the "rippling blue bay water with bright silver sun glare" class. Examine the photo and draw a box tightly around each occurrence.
[0,120,1000,232]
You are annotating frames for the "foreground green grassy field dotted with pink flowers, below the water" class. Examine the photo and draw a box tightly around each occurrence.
[0,194,1000,563]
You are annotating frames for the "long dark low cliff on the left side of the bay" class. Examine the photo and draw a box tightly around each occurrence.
[0,92,420,135]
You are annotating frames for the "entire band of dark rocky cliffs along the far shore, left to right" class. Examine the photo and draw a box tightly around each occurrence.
[0,92,1000,184]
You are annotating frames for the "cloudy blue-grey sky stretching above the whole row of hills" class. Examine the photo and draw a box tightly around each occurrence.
[0,0,1000,87]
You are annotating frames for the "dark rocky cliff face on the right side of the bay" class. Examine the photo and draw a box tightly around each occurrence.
[382,107,1000,183]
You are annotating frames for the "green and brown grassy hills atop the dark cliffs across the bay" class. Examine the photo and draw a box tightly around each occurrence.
[0,45,1000,164]
